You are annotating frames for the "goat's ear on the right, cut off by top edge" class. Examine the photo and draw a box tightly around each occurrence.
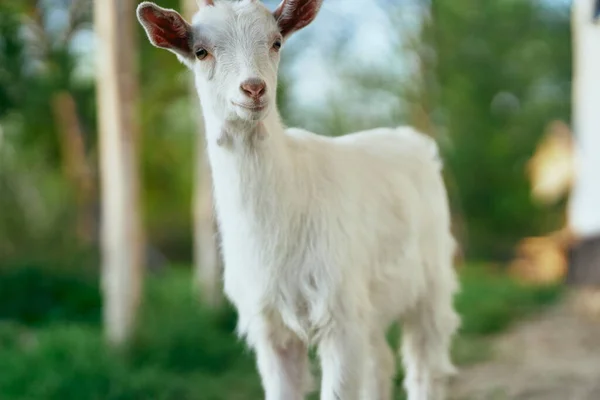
[273,0,323,38]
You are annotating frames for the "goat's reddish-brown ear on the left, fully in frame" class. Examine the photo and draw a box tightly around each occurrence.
[137,1,193,58]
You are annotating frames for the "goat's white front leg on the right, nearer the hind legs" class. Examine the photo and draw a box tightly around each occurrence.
[319,321,369,400]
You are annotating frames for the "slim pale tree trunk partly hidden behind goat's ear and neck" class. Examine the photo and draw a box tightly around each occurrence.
[183,0,223,307]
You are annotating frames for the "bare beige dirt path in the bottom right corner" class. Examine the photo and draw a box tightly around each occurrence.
[451,305,600,400]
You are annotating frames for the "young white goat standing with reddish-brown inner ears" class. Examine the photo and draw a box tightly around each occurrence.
[137,0,459,400]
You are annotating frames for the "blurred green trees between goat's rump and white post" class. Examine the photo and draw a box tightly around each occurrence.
[427,0,571,259]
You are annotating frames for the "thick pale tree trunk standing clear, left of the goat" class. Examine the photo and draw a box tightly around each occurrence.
[94,0,144,345]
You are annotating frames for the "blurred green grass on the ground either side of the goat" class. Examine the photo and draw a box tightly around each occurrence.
[0,268,560,400]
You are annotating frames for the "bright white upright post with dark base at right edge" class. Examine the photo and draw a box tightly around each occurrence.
[568,0,600,317]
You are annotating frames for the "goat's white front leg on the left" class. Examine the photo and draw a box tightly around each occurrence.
[254,335,310,400]
